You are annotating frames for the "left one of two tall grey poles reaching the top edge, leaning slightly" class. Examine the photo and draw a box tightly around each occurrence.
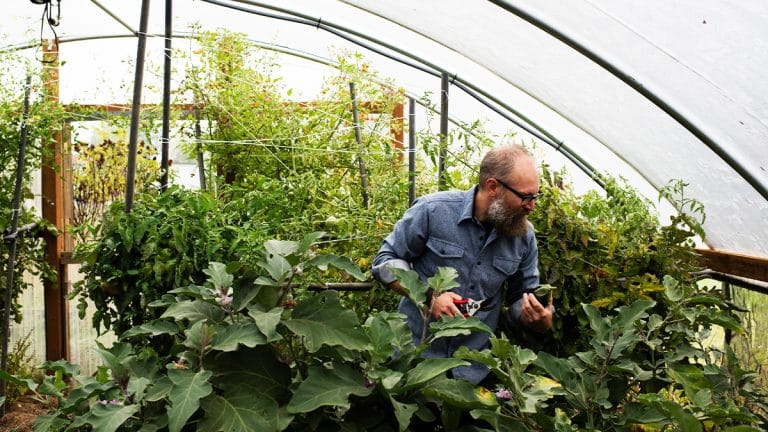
[125,0,149,213]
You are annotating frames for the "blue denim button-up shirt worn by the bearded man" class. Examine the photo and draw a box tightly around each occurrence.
[372,186,539,384]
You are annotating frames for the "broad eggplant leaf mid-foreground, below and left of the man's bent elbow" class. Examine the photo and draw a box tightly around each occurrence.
[284,291,370,353]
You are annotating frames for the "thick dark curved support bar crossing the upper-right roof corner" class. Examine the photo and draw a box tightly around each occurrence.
[490,0,768,200]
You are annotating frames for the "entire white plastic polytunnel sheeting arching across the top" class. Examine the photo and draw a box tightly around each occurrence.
[6,0,768,256]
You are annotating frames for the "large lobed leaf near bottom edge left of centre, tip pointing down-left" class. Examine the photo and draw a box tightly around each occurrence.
[288,364,373,414]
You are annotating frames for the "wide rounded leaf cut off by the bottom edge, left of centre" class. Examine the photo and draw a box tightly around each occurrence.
[198,392,281,432]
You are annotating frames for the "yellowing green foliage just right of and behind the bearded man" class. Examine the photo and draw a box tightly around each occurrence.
[524,168,712,355]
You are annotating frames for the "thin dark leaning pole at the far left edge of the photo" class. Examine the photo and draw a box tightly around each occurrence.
[0,75,32,417]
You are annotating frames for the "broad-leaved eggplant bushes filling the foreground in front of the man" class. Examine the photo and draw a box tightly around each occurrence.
[7,256,768,432]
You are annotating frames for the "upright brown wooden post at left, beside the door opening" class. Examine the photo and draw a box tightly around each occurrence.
[41,41,69,361]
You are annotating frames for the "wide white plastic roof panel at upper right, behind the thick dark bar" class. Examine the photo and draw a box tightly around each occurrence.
[347,0,768,256]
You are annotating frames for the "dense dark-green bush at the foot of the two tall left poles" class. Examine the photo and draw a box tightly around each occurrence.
[71,188,248,334]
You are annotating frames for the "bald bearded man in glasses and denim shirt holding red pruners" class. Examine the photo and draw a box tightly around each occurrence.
[372,145,553,384]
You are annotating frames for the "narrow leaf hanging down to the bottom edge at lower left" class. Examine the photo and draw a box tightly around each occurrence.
[168,369,213,432]
